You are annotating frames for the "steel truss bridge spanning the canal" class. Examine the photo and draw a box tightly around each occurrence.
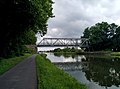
[37,38,89,48]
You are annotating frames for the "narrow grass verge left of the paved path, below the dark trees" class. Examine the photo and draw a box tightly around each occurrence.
[0,54,30,75]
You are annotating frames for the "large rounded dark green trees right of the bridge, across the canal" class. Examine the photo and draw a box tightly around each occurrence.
[82,22,120,51]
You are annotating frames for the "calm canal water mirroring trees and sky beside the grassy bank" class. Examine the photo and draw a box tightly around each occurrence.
[47,53,120,89]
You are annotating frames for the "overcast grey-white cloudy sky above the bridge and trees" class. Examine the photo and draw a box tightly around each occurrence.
[44,0,120,37]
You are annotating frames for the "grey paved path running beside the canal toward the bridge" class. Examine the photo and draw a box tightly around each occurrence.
[0,55,37,89]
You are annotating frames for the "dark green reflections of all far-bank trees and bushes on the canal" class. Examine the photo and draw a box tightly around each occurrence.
[54,53,120,88]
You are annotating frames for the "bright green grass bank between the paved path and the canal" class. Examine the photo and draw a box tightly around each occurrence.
[36,54,87,89]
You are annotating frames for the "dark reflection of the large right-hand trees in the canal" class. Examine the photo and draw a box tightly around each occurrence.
[85,58,120,87]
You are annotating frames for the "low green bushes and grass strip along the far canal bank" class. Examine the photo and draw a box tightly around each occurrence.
[51,48,120,57]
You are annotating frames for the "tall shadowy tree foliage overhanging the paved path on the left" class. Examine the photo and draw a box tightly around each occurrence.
[0,0,53,57]
